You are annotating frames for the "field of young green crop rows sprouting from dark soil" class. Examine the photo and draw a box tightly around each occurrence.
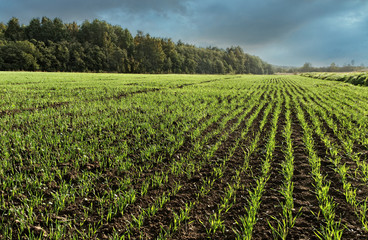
[0,72,368,239]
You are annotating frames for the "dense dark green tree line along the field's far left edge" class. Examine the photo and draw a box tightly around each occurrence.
[0,17,273,74]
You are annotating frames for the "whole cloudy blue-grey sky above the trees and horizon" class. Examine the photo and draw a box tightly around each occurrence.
[0,0,368,66]
